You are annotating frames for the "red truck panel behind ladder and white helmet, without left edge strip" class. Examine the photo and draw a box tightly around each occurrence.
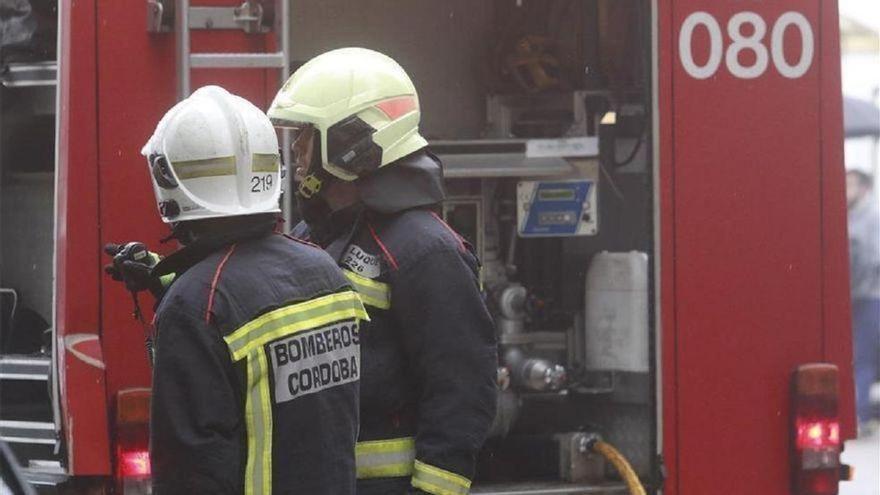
[97,0,278,406]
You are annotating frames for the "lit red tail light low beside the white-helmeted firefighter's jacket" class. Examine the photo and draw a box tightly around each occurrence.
[114,389,152,495]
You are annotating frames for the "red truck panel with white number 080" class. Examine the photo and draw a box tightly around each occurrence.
[659,0,851,494]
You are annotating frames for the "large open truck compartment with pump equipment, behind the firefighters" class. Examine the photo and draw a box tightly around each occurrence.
[291,0,660,494]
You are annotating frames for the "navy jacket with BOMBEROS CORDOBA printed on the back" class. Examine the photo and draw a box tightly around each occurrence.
[151,233,366,495]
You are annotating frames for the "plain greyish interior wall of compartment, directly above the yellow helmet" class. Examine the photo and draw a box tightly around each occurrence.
[291,0,493,139]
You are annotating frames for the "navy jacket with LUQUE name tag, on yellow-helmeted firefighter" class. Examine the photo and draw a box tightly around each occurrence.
[293,208,497,495]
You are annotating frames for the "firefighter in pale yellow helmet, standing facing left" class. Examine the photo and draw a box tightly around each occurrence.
[268,48,497,495]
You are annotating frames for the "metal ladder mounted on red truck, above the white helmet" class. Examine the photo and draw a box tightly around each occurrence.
[147,0,292,217]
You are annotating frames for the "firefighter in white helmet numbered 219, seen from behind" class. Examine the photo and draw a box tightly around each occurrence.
[109,86,366,495]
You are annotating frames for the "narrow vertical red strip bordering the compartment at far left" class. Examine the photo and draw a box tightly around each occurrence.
[55,0,110,475]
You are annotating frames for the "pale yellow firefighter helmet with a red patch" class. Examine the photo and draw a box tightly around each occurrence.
[267,48,428,192]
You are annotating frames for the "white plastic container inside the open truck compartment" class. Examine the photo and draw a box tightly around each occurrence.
[584,251,648,372]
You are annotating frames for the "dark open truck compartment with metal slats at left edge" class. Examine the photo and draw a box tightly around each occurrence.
[0,1,60,480]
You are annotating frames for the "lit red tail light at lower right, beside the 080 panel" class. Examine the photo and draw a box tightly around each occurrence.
[791,364,841,495]
